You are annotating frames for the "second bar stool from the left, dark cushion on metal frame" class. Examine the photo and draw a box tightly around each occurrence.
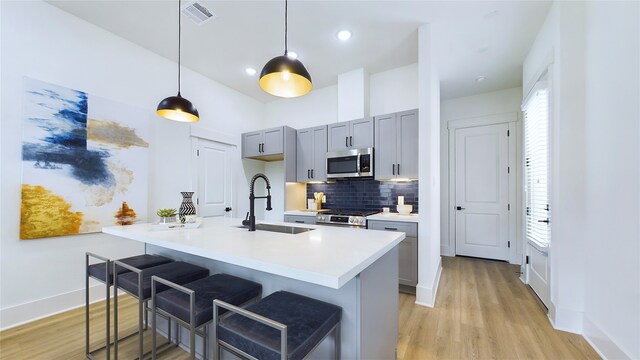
[113,261,209,360]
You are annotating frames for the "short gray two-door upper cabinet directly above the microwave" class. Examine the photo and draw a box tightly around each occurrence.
[327,118,373,151]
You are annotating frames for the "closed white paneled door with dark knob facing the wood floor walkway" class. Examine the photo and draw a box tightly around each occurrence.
[455,124,510,260]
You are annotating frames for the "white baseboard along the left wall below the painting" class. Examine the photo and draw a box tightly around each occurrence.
[0,284,105,331]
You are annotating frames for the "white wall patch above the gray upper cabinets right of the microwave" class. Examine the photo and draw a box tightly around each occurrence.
[369,63,418,116]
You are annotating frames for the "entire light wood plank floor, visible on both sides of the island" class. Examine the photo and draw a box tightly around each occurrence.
[0,257,599,360]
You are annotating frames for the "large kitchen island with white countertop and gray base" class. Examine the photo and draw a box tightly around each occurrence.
[103,218,405,359]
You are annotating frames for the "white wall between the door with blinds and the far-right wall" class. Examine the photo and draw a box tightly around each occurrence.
[523,2,586,333]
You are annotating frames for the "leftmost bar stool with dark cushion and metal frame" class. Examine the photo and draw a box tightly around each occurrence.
[85,252,173,359]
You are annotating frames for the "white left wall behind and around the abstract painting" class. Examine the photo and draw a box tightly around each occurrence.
[0,1,264,328]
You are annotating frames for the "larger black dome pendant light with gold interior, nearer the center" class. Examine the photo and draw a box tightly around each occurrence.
[260,0,313,98]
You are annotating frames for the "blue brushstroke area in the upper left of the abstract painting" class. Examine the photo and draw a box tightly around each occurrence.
[22,82,116,187]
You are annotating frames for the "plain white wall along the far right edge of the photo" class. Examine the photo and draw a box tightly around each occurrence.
[582,2,640,359]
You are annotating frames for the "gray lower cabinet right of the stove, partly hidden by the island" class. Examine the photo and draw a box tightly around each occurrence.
[367,220,418,286]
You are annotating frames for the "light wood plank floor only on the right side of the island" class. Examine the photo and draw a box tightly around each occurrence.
[398,257,600,360]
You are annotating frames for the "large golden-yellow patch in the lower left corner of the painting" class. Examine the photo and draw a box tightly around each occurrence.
[20,184,83,239]
